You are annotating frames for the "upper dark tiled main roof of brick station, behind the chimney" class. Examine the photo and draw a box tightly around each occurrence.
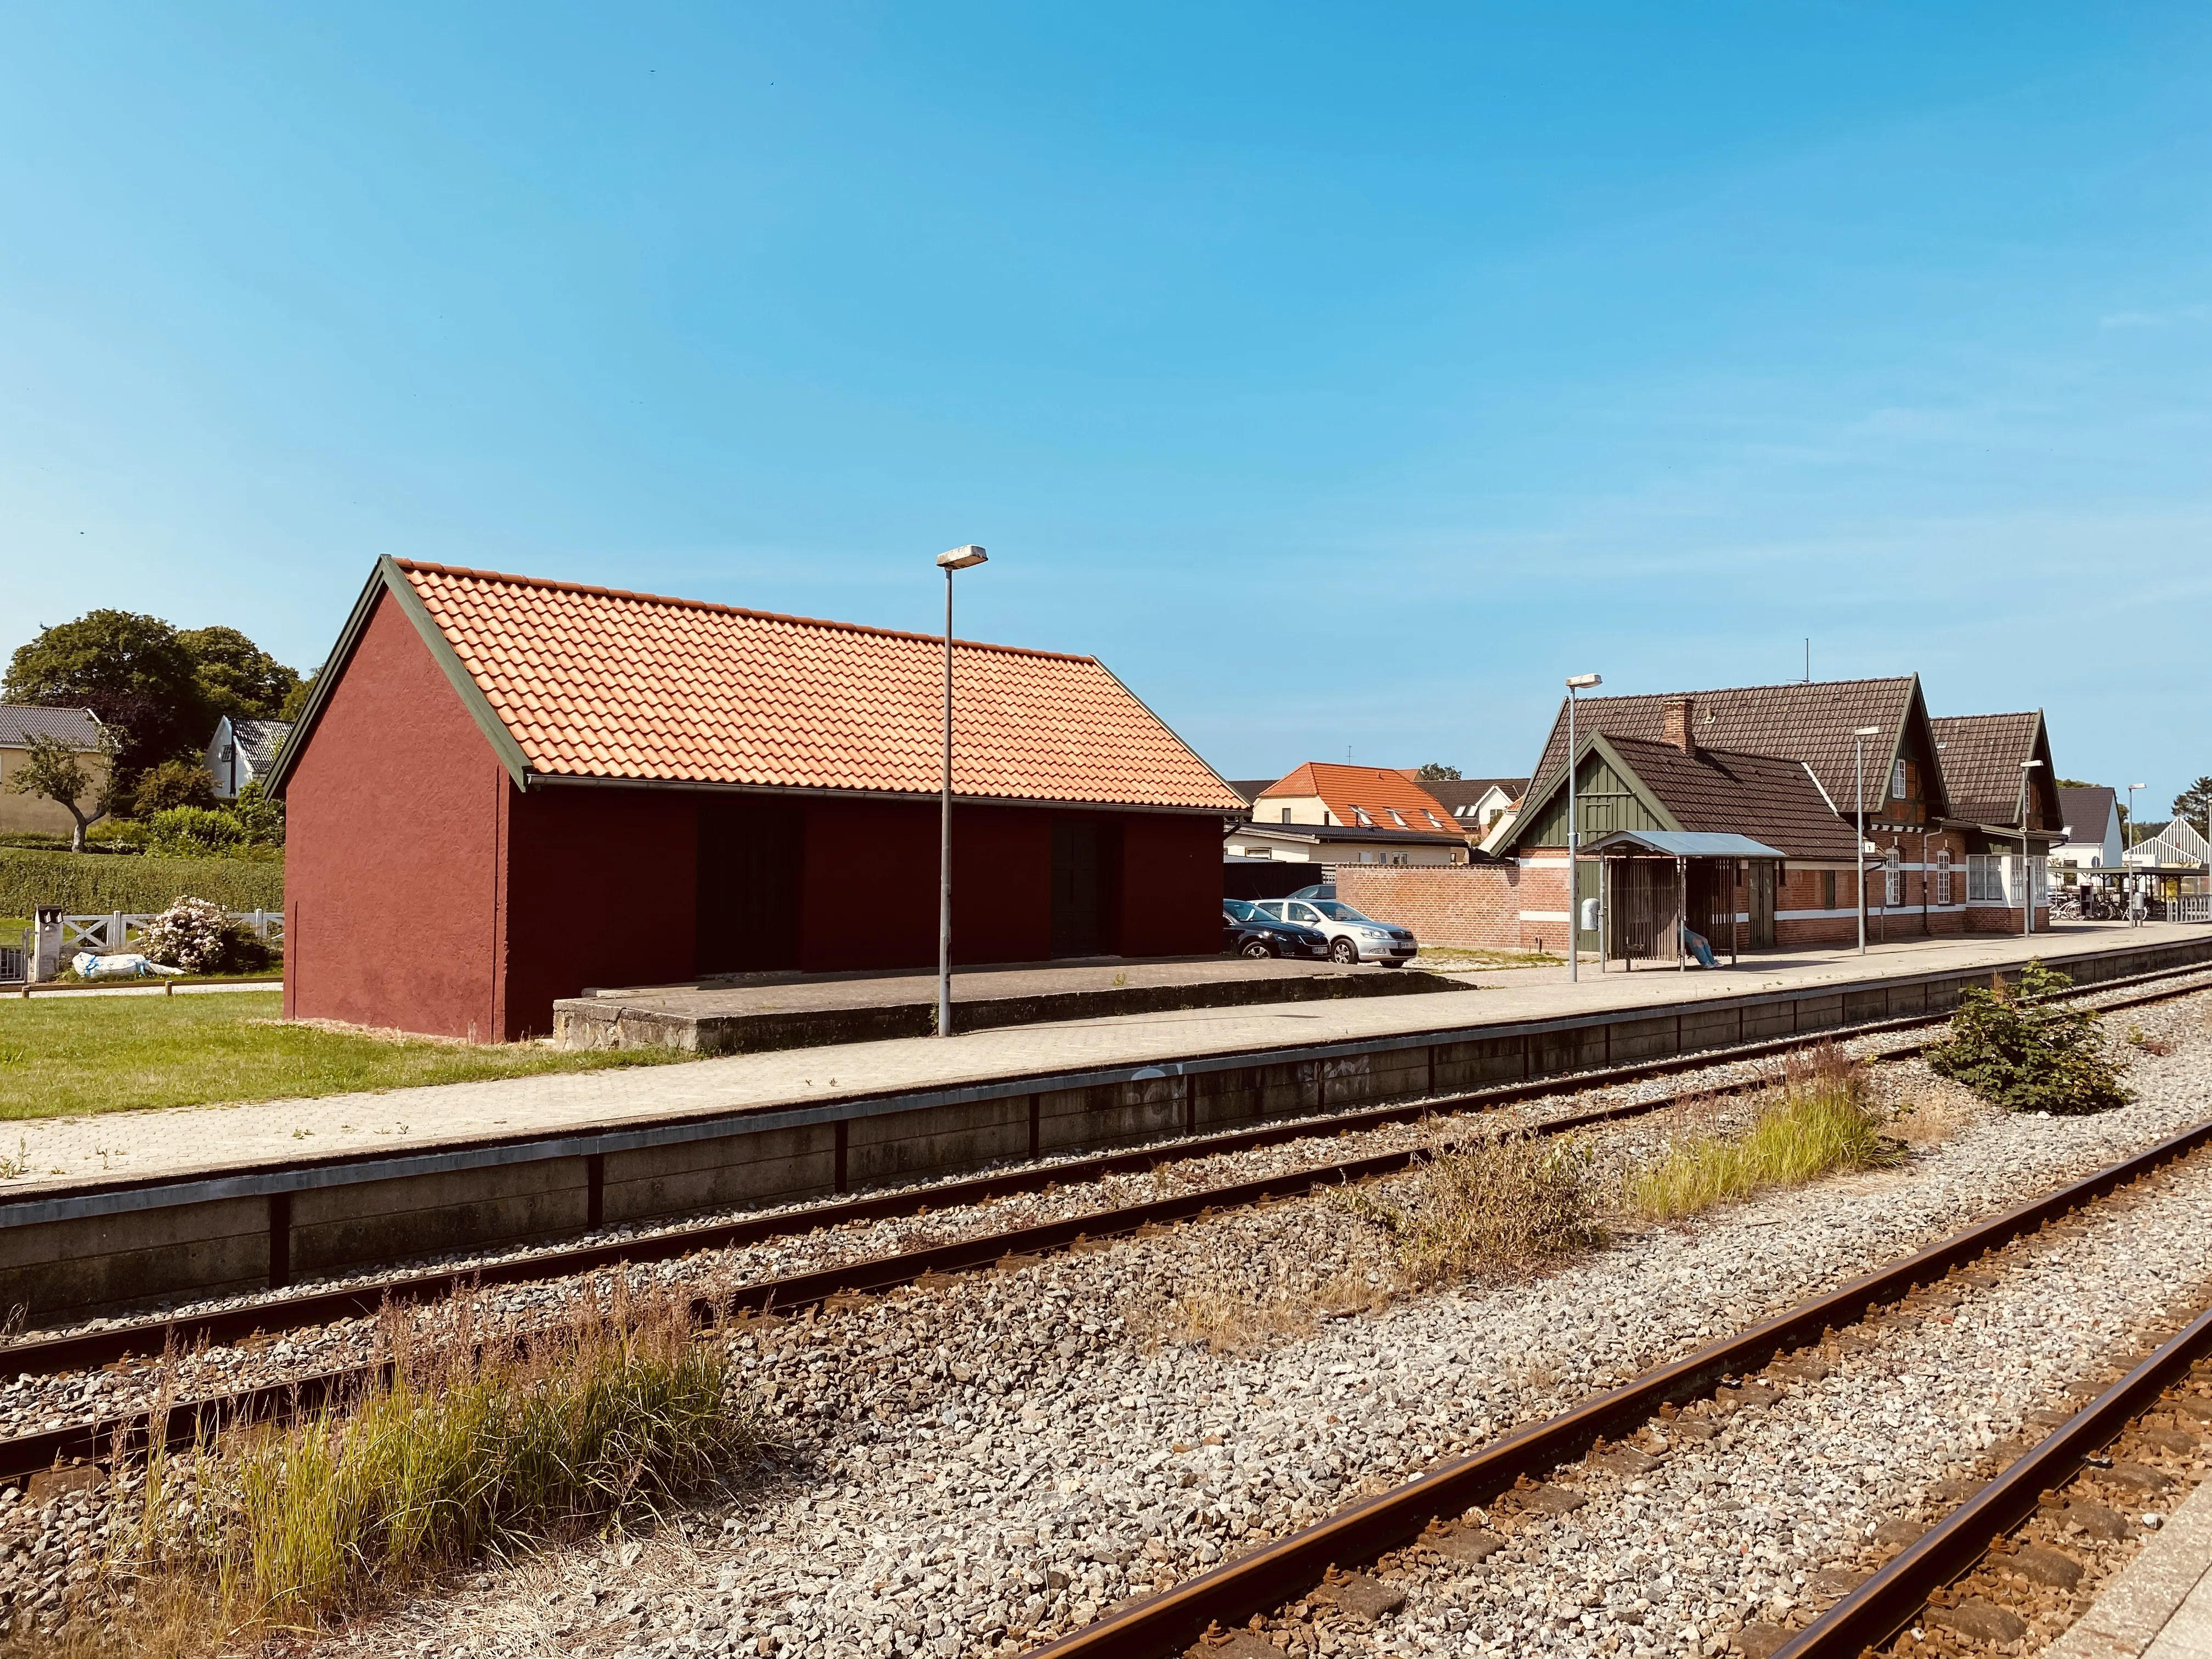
[1535,675,1918,834]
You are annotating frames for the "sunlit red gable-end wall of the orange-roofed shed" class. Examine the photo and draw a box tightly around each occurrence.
[283,595,513,1040]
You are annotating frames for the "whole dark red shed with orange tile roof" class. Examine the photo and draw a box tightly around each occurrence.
[272,560,1243,1040]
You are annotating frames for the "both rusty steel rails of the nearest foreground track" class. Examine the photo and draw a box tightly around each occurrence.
[1033,1121,2212,1659]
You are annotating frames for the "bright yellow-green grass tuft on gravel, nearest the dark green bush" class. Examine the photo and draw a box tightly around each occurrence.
[1621,1044,1903,1221]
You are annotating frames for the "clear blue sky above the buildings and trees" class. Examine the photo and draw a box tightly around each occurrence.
[0,0,2212,808]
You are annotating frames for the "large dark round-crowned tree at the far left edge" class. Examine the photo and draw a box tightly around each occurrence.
[0,611,215,783]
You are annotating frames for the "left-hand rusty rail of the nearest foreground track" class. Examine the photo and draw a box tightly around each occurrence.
[1031,1121,2212,1659]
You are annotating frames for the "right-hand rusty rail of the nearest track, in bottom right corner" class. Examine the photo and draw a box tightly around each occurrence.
[1774,1307,2212,1659]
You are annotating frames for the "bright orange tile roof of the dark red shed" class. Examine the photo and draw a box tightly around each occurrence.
[396,560,1243,812]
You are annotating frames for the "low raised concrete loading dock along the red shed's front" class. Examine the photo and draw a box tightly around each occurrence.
[553,956,1464,1055]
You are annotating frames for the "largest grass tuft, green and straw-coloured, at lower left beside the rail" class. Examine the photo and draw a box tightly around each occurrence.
[41,1278,759,1659]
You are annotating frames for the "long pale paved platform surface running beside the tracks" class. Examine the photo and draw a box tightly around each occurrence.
[0,922,2185,1203]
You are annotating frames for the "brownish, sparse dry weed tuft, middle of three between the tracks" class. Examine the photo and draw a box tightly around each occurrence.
[1340,1132,1606,1285]
